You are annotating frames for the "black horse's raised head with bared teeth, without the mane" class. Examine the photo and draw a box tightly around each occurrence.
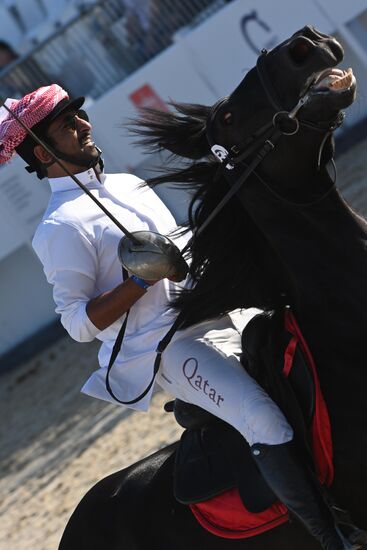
[217,26,356,140]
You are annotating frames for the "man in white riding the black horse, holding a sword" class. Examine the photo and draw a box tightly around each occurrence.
[0,85,356,550]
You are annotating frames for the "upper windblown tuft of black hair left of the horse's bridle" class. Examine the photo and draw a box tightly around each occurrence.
[130,103,210,160]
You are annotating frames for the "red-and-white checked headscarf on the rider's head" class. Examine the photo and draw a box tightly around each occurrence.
[0,84,69,165]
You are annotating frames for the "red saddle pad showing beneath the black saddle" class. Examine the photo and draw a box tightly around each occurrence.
[190,309,334,539]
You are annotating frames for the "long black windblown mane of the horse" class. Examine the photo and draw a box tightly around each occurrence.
[130,103,288,325]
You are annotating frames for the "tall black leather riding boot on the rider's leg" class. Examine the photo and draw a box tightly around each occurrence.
[251,442,352,550]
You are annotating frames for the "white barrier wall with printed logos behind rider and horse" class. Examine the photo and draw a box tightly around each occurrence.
[0,0,367,354]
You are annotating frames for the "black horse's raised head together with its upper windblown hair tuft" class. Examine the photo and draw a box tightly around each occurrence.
[137,26,356,171]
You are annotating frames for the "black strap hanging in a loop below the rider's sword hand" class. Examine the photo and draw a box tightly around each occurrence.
[106,268,183,405]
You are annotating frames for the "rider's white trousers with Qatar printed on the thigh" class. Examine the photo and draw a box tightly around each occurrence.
[156,310,293,445]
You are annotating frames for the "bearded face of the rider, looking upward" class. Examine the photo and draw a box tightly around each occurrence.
[47,110,99,166]
